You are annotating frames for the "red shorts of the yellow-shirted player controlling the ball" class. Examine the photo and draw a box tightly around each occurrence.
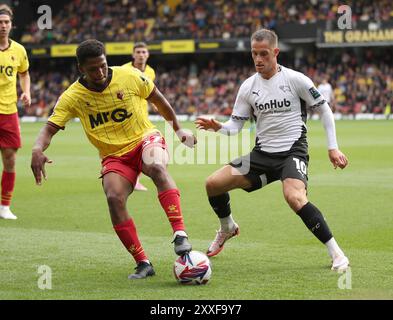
[101,133,167,186]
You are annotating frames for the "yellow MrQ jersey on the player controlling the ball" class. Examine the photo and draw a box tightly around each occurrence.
[48,67,157,158]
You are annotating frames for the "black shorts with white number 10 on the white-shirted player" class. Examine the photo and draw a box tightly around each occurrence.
[229,148,309,192]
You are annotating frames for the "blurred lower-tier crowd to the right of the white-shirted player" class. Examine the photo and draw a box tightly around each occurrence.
[295,49,393,114]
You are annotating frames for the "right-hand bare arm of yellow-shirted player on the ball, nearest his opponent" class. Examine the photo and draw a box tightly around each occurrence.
[147,87,197,148]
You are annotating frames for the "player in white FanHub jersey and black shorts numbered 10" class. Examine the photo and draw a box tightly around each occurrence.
[195,29,349,271]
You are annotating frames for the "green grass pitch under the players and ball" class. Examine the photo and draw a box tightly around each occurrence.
[0,121,393,300]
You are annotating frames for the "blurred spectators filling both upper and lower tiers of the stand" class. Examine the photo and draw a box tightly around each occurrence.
[11,0,393,117]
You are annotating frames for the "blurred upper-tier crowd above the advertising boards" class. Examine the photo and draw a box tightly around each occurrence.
[21,0,393,44]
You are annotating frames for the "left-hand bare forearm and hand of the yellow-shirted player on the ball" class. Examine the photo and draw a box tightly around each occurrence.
[31,124,59,185]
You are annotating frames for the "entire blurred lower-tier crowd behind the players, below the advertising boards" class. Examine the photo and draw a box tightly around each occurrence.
[22,50,393,117]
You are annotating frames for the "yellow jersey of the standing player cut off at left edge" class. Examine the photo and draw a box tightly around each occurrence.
[0,40,29,114]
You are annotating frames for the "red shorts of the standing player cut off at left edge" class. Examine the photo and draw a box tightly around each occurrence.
[0,112,22,149]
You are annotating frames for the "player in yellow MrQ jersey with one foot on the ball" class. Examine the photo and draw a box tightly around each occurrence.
[31,40,196,279]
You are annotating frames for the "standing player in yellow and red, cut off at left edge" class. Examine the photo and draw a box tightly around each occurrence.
[0,4,31,219]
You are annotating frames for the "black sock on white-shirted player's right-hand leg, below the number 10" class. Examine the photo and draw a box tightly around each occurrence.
[297,202,333,244]
